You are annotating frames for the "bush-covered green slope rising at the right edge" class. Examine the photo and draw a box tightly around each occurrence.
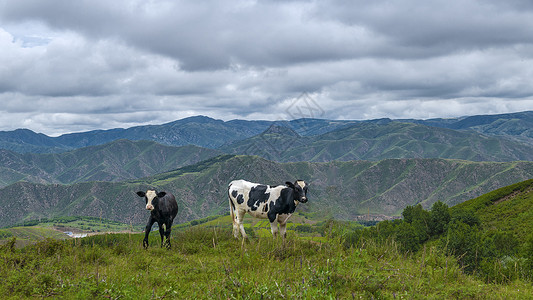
[345,180,533,282]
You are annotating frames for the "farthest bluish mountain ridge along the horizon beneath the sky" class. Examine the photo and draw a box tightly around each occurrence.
[0,111,533,153]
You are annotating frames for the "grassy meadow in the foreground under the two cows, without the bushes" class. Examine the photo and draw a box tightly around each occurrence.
[0,226,533,299]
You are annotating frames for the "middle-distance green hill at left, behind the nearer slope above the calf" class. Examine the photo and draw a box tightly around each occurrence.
[0,140,221,187]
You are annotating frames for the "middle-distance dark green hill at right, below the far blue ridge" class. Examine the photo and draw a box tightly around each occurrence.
[220,120,533,162]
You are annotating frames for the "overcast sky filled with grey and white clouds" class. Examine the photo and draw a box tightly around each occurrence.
[0,0,533,136]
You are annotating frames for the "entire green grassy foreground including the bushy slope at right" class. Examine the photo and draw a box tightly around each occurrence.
[0,180,533,299]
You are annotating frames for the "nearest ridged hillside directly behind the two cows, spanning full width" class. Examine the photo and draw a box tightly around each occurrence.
[0,155,533,226]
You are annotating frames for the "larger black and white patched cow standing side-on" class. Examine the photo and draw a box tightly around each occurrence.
[228,180,307,238]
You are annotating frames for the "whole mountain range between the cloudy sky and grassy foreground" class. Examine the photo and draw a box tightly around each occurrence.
[0,112,533,226]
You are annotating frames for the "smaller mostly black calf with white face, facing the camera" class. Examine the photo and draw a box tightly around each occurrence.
[137,190,178,249]
